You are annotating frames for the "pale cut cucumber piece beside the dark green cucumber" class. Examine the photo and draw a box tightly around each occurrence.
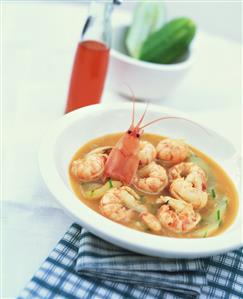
[125,1,165,58]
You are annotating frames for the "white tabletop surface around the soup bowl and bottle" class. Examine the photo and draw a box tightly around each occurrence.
[2,1,242,298]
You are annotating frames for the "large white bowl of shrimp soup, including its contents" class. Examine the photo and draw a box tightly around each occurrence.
[39,104,241,258]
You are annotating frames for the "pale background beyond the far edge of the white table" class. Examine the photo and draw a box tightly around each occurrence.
[64,0,242,42]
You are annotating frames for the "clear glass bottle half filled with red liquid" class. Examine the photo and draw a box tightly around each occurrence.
[65,0,121,113]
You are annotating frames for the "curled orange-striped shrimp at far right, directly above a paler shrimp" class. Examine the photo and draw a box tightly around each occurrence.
[168,162,207,191]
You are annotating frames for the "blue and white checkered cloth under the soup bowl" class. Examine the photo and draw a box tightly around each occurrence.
[18,224,243,299]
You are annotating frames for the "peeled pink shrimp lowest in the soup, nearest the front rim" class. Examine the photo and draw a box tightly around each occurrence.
[157,196,201,233]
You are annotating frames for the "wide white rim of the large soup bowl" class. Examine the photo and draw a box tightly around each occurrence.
[38,103,242,258]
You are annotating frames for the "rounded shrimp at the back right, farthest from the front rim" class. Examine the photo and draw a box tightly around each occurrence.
[156,138,189,167]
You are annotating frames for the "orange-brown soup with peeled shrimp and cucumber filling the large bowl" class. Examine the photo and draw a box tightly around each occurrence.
[69,132,238,238]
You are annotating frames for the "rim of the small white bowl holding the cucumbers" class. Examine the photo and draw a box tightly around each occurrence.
[111,25,195,72]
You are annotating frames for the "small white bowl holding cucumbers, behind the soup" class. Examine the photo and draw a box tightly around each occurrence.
[109,25,195,101]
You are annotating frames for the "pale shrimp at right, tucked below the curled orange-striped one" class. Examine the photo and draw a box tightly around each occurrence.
[170,178,208,209]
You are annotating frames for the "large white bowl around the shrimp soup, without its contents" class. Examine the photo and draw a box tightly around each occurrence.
[39,104,242,258]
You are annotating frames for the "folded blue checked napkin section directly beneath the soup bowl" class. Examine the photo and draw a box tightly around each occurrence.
[76,230,207,296]
